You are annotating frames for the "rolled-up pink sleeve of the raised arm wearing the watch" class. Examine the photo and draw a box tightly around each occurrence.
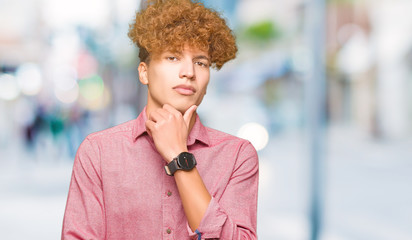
[187,142,259,240]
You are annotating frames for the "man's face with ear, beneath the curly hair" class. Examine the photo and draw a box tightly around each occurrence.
[139,47,210,113]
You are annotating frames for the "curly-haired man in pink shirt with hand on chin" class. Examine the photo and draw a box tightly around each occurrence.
[62,0,258,240]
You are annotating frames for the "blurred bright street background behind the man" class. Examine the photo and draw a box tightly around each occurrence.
[0,0,412,240]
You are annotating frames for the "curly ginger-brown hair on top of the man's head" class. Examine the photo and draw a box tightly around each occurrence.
[128,0,237,70]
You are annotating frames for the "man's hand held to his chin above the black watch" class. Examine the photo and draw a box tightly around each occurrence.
[146,104,197,163]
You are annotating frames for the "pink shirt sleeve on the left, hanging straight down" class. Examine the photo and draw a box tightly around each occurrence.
[62,138,105,240]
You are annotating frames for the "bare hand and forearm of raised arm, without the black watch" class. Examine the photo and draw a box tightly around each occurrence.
[146,104,211,231]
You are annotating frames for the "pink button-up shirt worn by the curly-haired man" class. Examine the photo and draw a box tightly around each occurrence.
[62,110,258,240]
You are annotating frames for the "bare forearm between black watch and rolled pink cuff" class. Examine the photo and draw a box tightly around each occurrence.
[174,168,211,231]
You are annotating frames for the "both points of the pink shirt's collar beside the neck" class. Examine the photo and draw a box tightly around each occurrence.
[133,107,210,146]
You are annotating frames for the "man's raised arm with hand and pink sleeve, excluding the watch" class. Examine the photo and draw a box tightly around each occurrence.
[146,105,258,239]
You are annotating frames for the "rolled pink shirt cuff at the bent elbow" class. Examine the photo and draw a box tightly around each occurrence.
[187,197,227,240]
